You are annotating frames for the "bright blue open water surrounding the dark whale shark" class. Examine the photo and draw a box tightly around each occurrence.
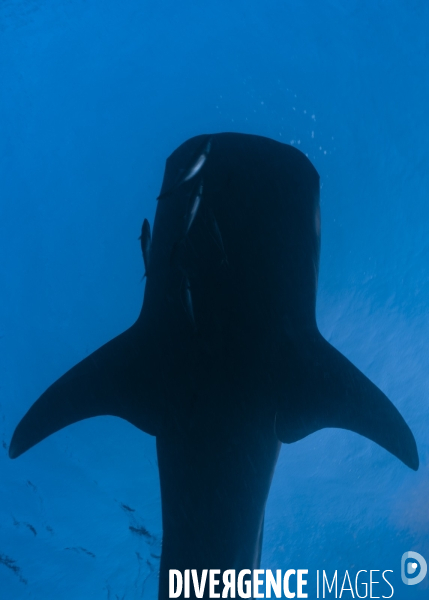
[0,0,429,600]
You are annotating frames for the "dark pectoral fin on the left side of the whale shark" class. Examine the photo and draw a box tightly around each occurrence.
[9,324,160,458]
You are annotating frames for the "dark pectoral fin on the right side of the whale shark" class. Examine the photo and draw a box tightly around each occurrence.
[276,334,419,471]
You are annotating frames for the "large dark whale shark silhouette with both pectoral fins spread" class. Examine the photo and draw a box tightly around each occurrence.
[9,133,419,600]
